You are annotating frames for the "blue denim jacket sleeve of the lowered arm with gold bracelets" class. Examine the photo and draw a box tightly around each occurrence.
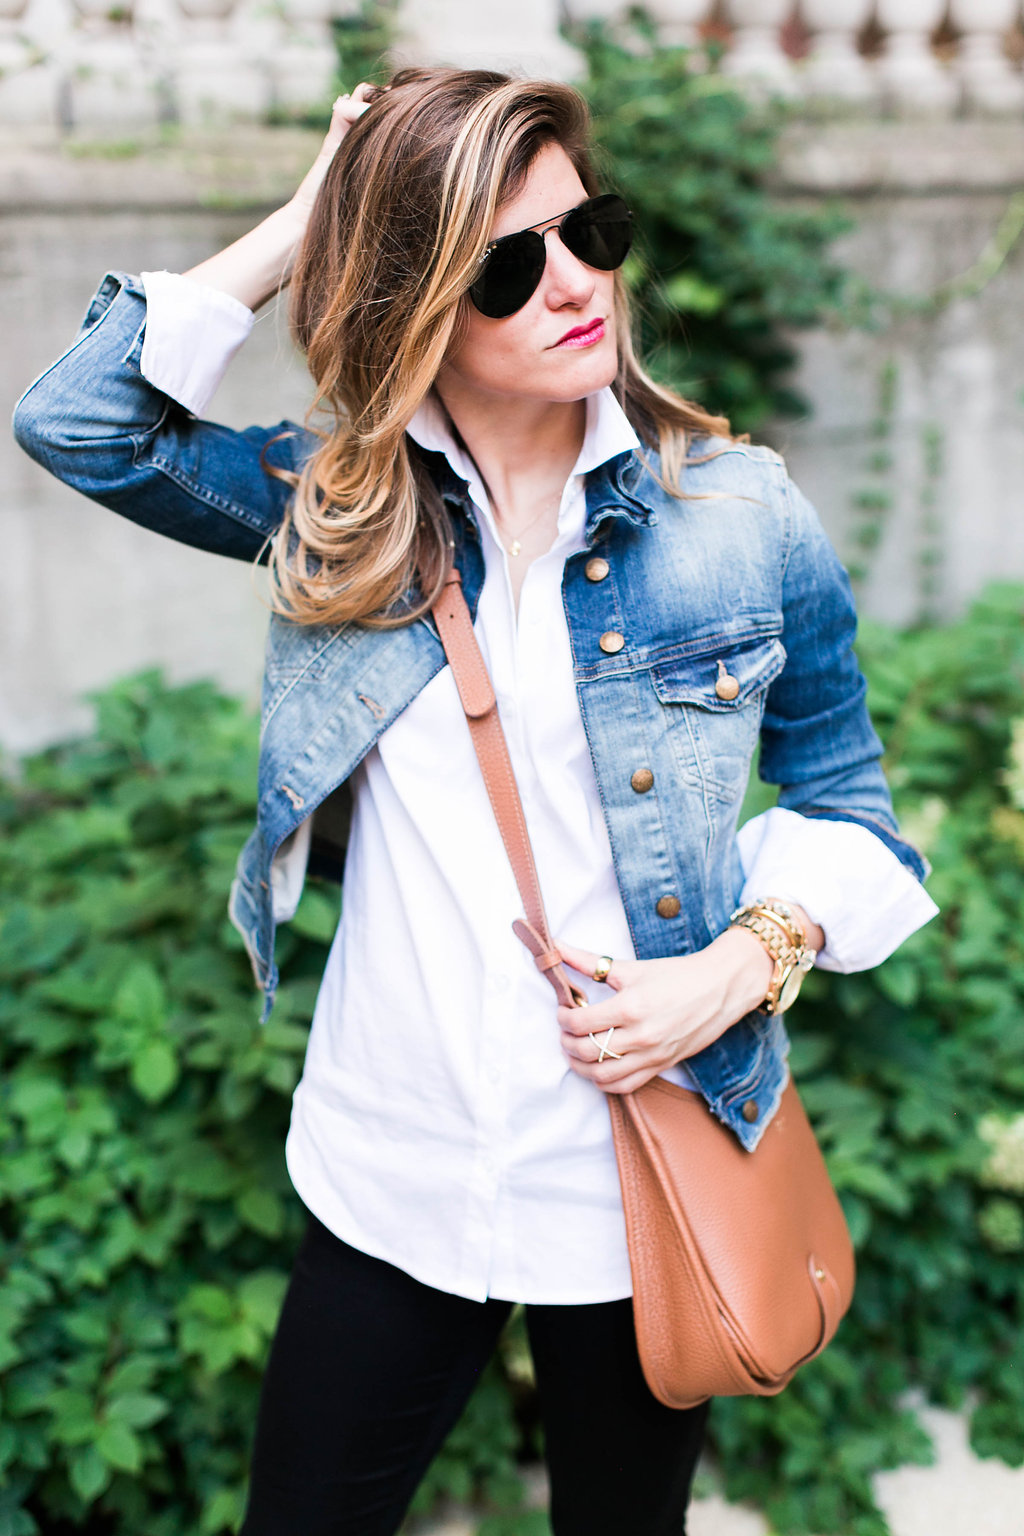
[760,481,927,880]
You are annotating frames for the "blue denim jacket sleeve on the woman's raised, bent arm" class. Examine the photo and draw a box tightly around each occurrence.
[14,273,300,561]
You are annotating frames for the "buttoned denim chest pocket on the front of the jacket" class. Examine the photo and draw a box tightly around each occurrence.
[651,636,786,802]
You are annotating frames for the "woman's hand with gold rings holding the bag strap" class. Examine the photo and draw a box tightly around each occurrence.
[559,928,772,1094]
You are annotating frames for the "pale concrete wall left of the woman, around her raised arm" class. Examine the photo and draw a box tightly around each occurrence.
[0,132,315,753]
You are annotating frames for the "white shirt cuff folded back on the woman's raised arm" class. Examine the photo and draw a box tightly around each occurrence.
[140,272,256,416]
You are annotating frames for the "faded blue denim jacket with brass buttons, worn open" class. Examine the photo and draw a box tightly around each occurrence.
[15,273,924,1147]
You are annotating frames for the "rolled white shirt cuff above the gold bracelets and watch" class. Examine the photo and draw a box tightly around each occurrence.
[737,806,938,971]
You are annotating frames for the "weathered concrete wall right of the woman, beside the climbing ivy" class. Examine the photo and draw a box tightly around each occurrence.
[772,123,1024,625]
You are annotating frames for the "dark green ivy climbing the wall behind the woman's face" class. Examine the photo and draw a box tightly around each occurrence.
[573,23,849,432]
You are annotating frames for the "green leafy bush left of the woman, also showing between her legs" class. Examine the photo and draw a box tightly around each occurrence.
[0,676,528,1536]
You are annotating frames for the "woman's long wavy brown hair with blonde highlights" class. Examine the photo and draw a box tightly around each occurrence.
[270,69,729,628]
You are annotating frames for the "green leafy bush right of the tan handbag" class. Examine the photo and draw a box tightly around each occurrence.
[712,588,1024,1536]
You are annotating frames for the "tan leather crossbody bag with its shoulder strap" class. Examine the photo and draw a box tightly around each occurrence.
[433,571,854,1409]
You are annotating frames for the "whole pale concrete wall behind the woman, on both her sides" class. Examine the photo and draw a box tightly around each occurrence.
[0,123,1024,751]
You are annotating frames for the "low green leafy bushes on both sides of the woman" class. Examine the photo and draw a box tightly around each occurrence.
[0,588,1024,1536]
